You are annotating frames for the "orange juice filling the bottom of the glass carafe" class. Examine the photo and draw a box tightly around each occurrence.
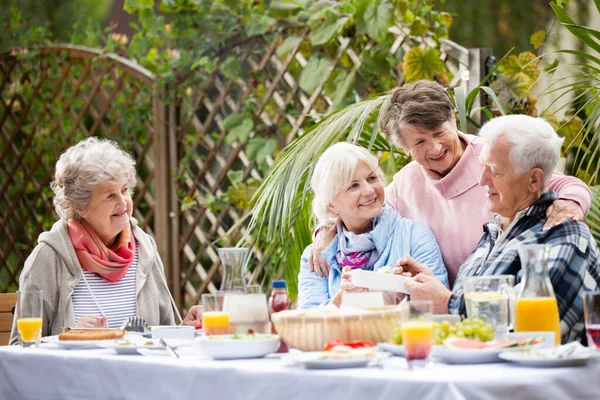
[515,297,560,346]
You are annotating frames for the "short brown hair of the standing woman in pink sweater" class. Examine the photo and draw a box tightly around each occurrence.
[381,81,454,147]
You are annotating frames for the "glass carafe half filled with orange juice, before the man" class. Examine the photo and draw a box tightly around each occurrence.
[515,244,561,345]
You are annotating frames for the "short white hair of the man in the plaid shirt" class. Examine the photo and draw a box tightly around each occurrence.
[479,115,564,188]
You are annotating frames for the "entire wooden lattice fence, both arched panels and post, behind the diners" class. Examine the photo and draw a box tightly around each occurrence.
[0,30,485,309]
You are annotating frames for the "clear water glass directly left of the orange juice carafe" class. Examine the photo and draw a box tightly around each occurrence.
[464,275,515,340]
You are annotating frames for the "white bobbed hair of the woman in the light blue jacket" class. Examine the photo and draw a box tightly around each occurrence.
[310,142,383,226]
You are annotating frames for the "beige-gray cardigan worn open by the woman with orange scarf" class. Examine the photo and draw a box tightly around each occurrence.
[10,219,175,344]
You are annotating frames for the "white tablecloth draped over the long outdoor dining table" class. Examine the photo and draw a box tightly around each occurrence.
[0,347,600,400]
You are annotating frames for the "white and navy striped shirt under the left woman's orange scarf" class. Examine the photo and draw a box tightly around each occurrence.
[72,245,138,328]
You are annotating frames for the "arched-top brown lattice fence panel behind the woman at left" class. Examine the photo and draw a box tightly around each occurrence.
[0,46,164,291]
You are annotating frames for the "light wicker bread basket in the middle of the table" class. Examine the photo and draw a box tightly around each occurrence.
[271,306,400,351]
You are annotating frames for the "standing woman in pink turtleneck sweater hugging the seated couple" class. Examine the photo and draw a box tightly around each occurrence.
[310,81,591,286]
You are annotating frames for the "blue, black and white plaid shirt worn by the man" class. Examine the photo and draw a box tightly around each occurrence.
[448,192,600,343]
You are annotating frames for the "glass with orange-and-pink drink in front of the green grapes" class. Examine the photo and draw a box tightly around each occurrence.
[401,300,433,369]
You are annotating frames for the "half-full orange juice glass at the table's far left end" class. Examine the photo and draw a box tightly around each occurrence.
[17,290,44,347]
